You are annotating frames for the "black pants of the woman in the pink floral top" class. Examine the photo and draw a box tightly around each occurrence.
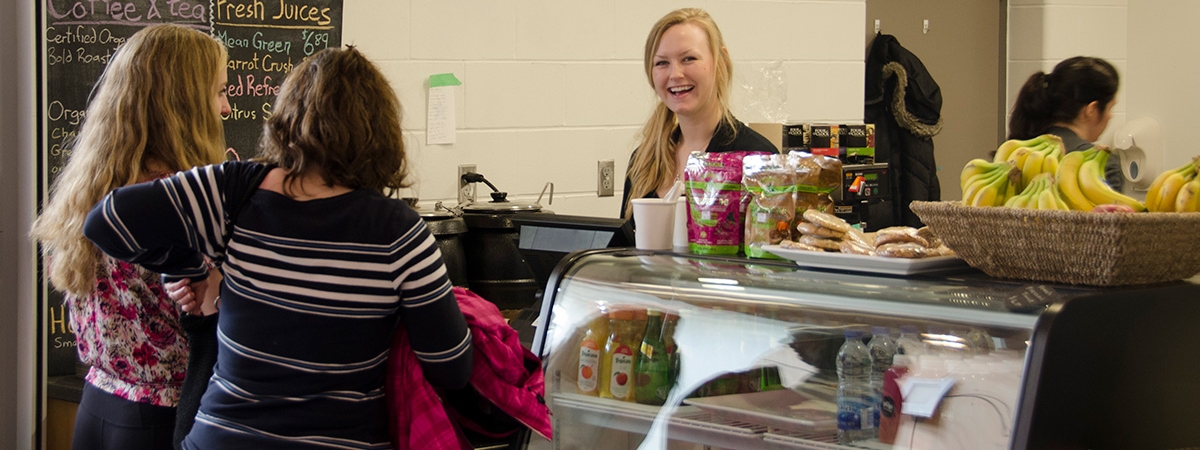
[71,383,175,450]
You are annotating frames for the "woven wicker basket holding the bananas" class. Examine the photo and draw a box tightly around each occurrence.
[910,202,1200,286]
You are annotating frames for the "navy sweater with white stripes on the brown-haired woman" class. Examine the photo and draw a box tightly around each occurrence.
[84,162,472,449]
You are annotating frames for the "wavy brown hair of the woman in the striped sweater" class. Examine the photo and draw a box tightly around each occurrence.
[258,47,410,192]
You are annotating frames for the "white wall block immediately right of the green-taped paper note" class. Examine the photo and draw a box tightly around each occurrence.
[463,62,566,128]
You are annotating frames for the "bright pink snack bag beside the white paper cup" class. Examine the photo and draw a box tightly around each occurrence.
[684,151,766,254]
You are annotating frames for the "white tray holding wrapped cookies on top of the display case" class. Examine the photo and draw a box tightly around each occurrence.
[762,245,968,275]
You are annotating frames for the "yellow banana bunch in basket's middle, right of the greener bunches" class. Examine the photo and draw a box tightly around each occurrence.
[1055,146,1146,212]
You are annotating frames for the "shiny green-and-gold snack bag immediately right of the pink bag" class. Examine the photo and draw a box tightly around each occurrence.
[742,155,797,259]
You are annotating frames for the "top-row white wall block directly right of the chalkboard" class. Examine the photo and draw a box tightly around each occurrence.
[342,0,412,61]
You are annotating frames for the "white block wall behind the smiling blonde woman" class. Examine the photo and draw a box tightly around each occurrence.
[343,0,865,216]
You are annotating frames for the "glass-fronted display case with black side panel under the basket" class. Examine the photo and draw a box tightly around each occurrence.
[533,250,1200,450]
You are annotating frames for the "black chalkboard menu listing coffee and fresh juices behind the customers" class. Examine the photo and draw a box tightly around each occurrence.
[37,0,342,377]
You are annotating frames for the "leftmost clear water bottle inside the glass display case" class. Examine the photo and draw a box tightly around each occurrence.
[838,330,875,444]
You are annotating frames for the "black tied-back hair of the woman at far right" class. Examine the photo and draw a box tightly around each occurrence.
[1008,56,1121,139]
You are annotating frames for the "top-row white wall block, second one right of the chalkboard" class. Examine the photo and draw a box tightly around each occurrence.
[412,0,517,60]
